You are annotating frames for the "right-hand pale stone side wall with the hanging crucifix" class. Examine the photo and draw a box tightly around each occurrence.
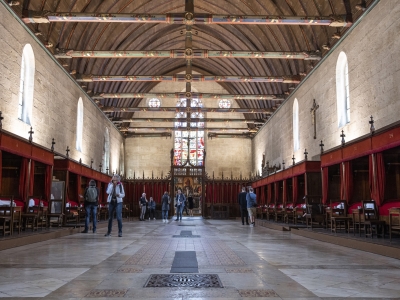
[252,1,400,172]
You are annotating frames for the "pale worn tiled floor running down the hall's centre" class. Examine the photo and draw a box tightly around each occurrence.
[0,218,400,300]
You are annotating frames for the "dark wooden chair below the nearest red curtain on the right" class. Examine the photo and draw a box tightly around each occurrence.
[361,200,386,238]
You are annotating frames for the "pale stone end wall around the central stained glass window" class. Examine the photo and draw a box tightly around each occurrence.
[125,73,251,177]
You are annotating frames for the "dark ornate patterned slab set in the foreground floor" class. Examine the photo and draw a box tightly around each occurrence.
[145,274,223,288]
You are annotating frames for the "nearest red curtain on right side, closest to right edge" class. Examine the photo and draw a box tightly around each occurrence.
[369,152,386,206]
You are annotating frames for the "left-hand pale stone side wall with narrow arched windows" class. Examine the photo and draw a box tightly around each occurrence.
[0,5,124,171]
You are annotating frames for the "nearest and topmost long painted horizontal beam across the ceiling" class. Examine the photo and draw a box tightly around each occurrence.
[22,10,352,27]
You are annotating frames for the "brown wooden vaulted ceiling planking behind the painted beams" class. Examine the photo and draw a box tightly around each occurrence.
[13,0,373,137]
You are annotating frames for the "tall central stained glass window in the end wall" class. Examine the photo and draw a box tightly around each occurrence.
[174,99,204,166]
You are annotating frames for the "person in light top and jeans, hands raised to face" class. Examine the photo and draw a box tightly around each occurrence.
[104,175,125,237]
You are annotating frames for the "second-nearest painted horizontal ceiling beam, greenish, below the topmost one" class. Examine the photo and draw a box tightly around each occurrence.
[54,49,322,61]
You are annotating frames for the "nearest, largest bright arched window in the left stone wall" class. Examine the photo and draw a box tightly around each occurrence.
[18,44,35,125]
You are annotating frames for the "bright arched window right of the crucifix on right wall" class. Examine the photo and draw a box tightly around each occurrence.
[336,52,350,127]
